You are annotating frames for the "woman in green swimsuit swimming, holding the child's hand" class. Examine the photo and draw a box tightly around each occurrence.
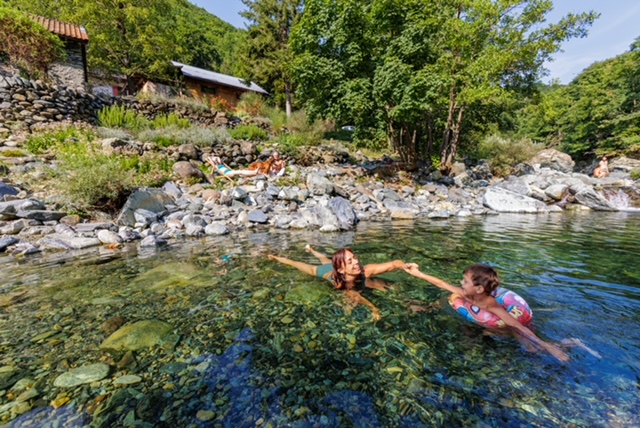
[268,244,418,321]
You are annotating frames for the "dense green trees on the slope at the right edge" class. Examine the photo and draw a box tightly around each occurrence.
[518,38,640,157]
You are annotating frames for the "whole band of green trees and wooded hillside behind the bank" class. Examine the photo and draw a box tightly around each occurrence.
[0,0,640,169]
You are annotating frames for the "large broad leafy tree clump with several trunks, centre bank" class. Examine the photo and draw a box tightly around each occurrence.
[292,0,596,167]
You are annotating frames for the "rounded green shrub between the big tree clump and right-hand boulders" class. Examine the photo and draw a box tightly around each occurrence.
[478,134,541,176]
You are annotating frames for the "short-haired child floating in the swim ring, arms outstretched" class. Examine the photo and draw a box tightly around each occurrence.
[405,264,569,361]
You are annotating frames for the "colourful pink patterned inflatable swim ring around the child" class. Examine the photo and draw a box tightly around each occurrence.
[449,287,533,328]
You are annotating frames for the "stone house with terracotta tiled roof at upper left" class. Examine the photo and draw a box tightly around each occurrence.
[29,15,89,91]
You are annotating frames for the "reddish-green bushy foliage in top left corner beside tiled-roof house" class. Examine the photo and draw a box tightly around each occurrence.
[0,7,64,78]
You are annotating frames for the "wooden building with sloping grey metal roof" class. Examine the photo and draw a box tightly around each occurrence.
[171,61,268,107]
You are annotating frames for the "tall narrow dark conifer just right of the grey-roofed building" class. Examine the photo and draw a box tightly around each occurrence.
[242,0,304,116]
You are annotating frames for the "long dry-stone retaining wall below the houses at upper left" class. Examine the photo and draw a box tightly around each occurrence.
[0,76,228,135]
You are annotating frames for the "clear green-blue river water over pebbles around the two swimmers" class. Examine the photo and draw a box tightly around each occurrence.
[0,213,640,427]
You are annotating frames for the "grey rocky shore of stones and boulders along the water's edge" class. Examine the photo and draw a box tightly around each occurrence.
[0,132,640,255]
